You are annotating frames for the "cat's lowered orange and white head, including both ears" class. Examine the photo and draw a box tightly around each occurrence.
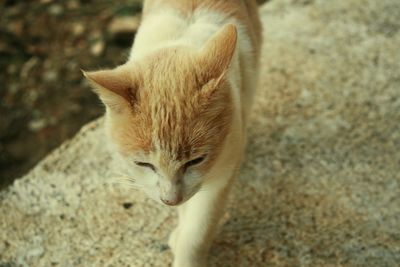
[84,24,237,205]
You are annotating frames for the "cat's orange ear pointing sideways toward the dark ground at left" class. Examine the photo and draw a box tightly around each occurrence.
[82,66,136,112]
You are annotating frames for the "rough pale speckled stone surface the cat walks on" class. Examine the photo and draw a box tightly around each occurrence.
[0,0,400,267]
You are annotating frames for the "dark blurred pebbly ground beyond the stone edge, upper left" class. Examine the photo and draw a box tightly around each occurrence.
[0,0,266,189]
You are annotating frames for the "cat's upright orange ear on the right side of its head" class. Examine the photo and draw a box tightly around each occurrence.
[199,24,237,94]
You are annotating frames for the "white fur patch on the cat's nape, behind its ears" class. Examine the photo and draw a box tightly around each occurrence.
[129,9,226,61]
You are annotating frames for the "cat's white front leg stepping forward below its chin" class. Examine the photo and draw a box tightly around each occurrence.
[171,180,230,267]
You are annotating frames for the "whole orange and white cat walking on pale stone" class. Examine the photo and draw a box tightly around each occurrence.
[84,0,262,267]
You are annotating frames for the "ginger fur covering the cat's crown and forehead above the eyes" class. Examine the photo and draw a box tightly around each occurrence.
[112,49,231,161]
